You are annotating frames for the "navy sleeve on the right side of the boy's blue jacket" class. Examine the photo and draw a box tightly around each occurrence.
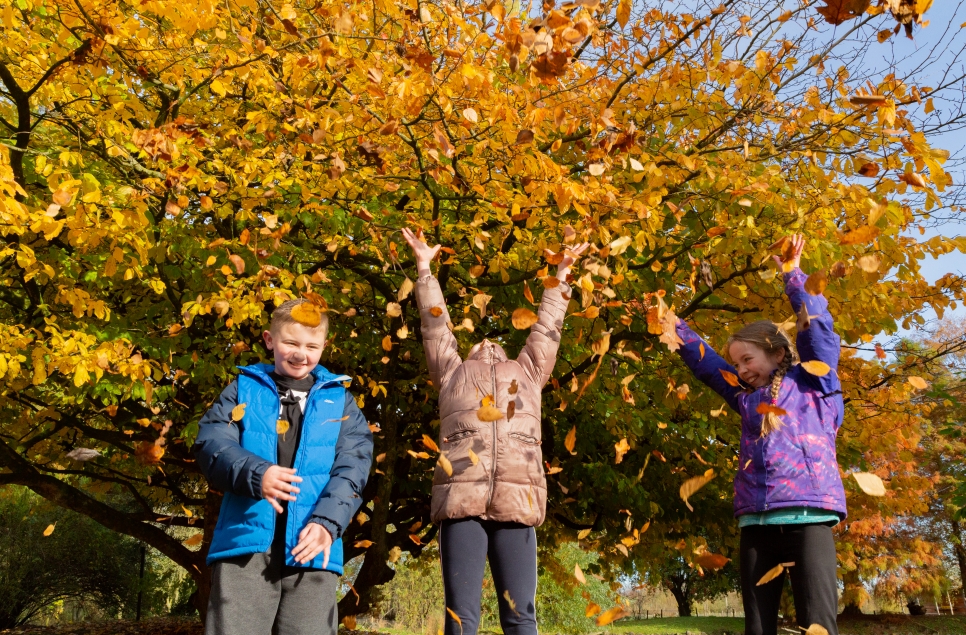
[310,391,372,540]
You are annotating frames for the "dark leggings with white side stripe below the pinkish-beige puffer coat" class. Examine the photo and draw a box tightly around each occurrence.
[439,518,537,635]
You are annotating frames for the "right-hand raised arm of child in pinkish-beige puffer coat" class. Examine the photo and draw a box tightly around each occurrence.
[517,243,590,386]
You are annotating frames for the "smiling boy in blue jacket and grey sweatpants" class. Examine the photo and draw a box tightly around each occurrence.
[194,300,372,635]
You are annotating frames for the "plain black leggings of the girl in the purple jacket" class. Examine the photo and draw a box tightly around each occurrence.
[740,525,838,635]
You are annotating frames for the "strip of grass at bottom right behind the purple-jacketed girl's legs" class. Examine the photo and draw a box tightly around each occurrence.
[603,615,966,635]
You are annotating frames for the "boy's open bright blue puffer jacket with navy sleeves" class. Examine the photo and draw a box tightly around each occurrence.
[193,364,372,575]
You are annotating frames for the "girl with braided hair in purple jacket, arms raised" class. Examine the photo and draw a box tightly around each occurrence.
[677,235,846,635]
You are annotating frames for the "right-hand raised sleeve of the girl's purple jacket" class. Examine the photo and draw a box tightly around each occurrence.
[784,269,842,395]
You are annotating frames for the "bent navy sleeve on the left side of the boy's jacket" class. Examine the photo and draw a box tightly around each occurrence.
[192,381,272,498]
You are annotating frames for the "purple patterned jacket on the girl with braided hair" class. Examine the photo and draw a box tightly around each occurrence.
[677,269,846,519]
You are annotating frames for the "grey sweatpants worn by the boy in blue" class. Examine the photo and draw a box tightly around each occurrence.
[205,549,339,635]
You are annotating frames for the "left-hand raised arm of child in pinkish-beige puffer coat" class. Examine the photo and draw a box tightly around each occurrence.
[402,228,462,389]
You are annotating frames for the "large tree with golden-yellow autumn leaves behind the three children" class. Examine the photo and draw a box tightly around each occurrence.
[0,0,966,615]
